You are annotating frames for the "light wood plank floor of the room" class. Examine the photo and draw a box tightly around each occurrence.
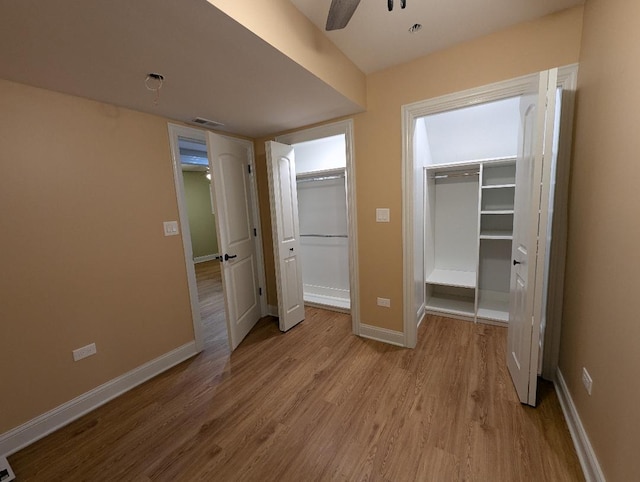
[10,264,584,482]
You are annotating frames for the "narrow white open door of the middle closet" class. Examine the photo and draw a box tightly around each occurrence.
[266,141,304,331]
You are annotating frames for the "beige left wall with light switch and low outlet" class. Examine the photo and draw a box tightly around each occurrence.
[0,80,193,433]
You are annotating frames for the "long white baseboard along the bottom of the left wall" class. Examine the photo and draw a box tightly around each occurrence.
[0,341,198,456]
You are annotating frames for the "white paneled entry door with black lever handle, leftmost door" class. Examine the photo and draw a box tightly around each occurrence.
[207,132,260,350]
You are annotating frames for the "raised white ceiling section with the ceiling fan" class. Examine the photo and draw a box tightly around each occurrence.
[291,0,584,73]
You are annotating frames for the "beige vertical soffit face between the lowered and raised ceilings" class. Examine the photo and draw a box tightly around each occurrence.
[208,0,366,108]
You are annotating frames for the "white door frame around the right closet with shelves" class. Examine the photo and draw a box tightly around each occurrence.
[402,64,578,350]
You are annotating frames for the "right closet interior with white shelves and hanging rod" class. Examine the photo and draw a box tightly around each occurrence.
[415,96,521,325]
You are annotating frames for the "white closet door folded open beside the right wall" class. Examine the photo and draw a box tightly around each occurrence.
[507,69,557,405]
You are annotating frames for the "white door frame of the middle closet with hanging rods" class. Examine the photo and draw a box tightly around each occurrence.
[275,119,360,335]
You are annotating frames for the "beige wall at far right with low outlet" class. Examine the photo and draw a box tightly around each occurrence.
[560,0,640,482]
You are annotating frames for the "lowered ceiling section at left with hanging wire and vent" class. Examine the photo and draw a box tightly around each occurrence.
[0,0,361,137]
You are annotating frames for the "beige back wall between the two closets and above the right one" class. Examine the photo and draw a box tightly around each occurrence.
[256,7,582,331]
